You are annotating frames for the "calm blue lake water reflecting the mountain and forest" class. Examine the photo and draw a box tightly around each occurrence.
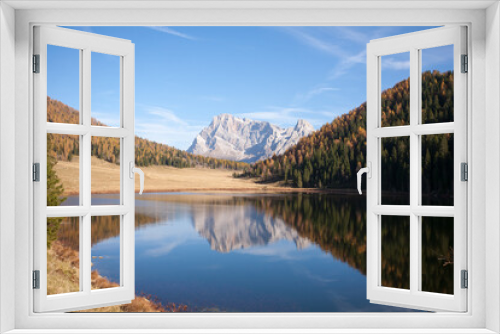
[59,194,453,312]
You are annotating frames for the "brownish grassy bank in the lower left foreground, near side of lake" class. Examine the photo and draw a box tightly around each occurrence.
[47,241,187,312]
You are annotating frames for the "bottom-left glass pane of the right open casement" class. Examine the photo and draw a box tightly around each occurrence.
[381,216,410,289]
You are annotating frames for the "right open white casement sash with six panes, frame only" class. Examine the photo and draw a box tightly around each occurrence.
[366,26,468,312]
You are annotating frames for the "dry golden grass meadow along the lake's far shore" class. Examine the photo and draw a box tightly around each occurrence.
[55,157,297,195]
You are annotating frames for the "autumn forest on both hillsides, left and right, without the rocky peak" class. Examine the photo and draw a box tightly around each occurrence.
[47,71,453,204]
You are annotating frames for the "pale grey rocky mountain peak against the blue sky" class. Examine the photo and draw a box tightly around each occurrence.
[187,114,314,163]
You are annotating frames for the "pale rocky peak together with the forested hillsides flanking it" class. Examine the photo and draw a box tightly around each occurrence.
[47,71,454,193]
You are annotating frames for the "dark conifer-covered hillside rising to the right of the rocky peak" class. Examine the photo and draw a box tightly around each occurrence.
[241,71,453,194]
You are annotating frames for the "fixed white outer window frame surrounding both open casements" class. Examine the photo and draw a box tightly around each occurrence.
[0,1,500,333]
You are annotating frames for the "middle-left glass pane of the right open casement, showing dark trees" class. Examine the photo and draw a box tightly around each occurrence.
[381,137,410,205]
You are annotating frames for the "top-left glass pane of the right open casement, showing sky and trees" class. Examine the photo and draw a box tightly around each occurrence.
[380,52,410,126]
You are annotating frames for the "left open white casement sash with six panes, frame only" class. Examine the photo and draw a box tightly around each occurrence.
[33,26,135,312]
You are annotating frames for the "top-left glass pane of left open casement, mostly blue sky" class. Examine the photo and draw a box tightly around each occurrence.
[47,45,80,124]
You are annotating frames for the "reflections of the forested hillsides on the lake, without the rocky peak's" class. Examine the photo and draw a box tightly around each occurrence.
[58,194,453,294]
